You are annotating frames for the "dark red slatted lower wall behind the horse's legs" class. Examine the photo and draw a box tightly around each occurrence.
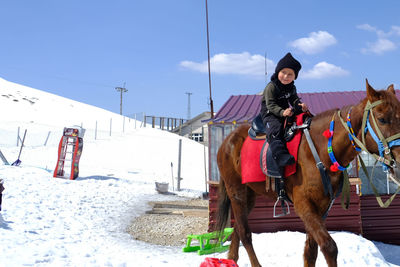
[209,182,400,245]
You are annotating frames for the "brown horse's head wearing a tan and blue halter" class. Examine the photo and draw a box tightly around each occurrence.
[362,80,400,179]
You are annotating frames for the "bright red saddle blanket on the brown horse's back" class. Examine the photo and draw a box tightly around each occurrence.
[240,113,306,184]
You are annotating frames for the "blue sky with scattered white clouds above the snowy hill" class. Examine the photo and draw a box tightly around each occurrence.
[0,0,400,119]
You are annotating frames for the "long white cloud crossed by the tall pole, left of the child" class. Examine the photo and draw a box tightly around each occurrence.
[179,52,275,77]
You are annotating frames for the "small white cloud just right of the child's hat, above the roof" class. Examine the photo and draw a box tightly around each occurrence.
[300,61,350,79]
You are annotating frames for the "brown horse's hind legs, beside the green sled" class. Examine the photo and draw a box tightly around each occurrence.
[227,185,261,267]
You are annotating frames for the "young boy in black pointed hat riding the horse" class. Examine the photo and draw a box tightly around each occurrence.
[260,53,308,209]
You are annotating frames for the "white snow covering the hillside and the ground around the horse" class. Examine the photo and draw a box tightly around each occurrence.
[0,76,400,267]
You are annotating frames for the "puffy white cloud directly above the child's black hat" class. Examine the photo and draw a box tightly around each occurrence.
[289,31,337,54]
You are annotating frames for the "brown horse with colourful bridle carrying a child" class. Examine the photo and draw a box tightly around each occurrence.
[217,81,400,267]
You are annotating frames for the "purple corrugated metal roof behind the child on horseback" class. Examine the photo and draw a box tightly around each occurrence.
[209,90,400,123]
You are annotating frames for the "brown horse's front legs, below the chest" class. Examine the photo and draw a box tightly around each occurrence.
[296,201,338,267]
